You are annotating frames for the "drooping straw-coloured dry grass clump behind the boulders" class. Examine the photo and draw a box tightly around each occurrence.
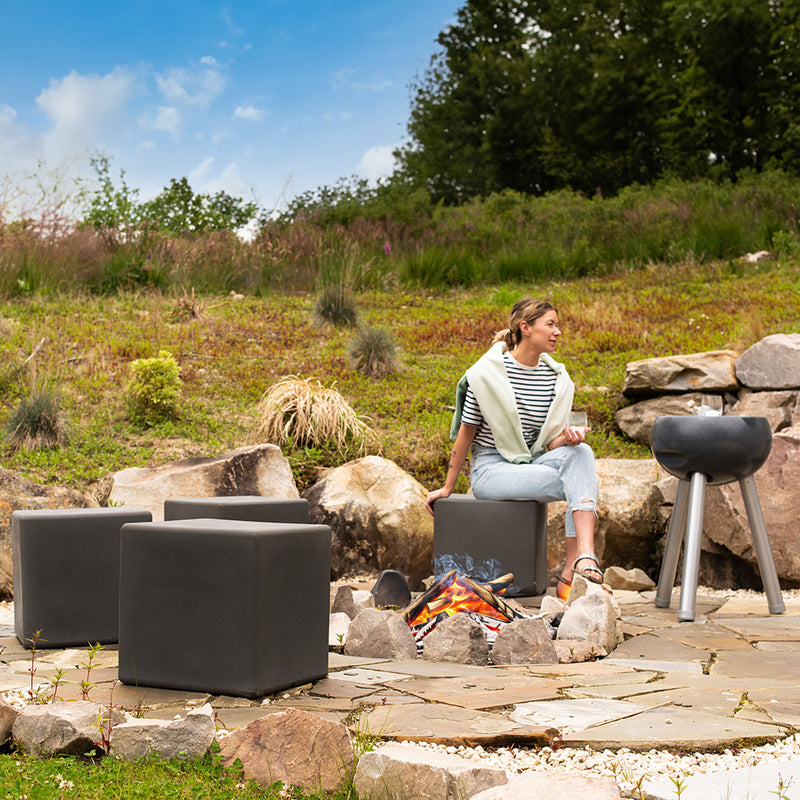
[256,375,379,455]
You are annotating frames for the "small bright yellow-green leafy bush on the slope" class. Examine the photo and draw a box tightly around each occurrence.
[127,350,181,425]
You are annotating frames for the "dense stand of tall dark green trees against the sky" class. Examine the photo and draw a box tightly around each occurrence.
[398,0,800,203]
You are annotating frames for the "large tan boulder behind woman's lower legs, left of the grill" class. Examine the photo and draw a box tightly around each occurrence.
[547,458,666,580]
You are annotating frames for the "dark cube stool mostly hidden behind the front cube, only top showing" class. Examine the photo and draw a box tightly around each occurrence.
[164,495,308,524]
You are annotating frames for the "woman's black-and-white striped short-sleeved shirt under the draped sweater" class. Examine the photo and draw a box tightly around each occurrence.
[461,352,557,447]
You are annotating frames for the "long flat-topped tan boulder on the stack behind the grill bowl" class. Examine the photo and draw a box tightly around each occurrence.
[622,350,739,397]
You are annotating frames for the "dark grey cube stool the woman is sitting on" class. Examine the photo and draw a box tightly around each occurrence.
[433,494,547,596]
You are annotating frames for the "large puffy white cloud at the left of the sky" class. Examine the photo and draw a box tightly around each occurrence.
[36,67,134,157]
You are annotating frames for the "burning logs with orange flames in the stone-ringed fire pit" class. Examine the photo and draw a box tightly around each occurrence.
[402,570,526,648]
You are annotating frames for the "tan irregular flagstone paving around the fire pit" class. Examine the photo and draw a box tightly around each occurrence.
[0,590,800,756]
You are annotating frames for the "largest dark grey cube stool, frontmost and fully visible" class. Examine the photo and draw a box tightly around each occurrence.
[119,519,331,697]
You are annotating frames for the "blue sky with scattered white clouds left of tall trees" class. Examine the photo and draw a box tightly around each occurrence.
[0,0,462,217]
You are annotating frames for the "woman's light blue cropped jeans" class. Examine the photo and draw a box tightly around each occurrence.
[470,442,597,537]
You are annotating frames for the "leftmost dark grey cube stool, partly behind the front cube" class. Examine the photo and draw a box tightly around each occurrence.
[11,508,152,647]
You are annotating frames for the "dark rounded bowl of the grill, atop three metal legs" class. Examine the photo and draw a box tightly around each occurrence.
[650,416,772,486]
